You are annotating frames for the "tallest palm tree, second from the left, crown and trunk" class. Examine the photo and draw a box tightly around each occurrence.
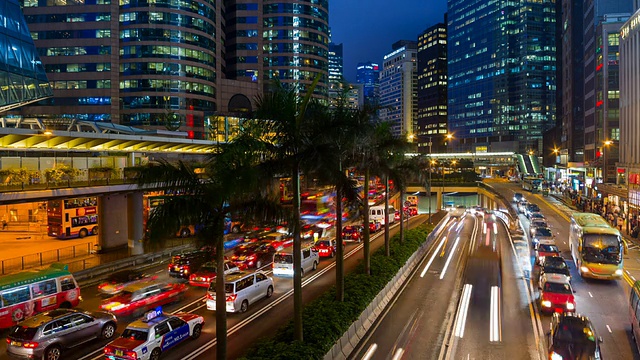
[250,76,321,341]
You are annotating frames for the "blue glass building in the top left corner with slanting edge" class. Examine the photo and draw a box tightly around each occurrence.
[0,0,53,112]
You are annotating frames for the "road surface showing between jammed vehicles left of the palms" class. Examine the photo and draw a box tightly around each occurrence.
[0,215,427,360]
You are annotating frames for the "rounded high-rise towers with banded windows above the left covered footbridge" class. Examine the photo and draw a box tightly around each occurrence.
[16,0,328,139]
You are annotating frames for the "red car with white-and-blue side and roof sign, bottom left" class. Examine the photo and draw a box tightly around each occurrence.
[104,308,204,360]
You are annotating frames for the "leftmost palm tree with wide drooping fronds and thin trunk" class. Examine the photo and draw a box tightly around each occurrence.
[139,131,285,359]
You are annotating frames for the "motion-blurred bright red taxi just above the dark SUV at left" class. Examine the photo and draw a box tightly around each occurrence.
[100,282,187,317]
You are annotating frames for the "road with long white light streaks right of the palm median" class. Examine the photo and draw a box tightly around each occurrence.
[352,210,538,360]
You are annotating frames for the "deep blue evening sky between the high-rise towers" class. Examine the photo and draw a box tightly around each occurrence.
[329,0,447,83]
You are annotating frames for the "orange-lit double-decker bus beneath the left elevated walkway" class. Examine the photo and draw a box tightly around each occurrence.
[47,196,98,239]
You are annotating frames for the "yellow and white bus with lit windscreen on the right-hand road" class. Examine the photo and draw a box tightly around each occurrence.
[569,213,625,280]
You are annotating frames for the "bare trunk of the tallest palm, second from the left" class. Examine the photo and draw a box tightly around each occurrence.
[291,163,303,341]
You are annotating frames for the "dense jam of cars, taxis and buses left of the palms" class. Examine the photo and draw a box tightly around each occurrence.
[0,186,420,360]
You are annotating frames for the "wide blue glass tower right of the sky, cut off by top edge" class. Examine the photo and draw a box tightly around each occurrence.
[447,0,556,153]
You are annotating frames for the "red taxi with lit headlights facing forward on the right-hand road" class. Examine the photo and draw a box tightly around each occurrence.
[539,273,576,313]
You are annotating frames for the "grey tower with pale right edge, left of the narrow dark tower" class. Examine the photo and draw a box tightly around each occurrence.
[378,40,418,137]
